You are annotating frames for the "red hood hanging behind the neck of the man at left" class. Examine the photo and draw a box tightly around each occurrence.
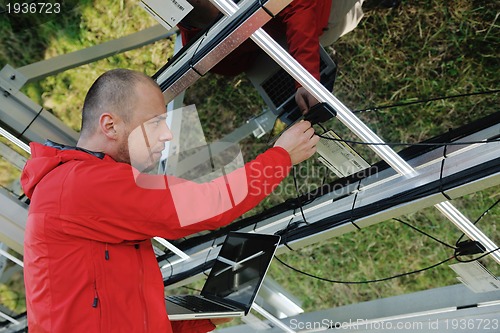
[21,141,110,198]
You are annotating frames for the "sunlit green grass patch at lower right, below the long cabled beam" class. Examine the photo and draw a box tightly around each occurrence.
[270,191,500,311]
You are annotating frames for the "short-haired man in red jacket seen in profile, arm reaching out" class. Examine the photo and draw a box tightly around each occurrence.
[21,69,319,333]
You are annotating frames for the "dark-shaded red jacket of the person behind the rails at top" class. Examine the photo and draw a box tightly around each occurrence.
[179,0,332,80]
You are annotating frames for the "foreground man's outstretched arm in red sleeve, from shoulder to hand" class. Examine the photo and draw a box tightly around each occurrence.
[58,122,318,243]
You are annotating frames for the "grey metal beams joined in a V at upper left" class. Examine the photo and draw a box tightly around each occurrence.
[0,24,175,145]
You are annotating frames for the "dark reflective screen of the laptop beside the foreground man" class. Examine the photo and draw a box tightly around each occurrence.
[201,232,280,313]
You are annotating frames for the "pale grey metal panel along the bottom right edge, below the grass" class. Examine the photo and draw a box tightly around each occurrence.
[217,284,500,333]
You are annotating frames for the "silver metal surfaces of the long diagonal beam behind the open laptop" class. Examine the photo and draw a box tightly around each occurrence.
[162,124,500,288]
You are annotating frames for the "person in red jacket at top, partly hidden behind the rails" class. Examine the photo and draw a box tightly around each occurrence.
[178,0,364,113]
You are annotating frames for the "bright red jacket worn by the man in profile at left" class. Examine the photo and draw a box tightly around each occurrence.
[21,143,290,333]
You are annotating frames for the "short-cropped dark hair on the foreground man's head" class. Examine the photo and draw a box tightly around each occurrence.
[81,68,158,135]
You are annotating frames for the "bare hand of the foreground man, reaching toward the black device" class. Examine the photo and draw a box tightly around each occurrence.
[274,121,319,165]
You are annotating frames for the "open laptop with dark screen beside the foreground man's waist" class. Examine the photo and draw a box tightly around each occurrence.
[165,232,280,320]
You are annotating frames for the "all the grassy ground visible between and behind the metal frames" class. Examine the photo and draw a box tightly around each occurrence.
[0,0,500,322]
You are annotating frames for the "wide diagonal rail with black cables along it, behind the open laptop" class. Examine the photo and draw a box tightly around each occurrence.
[160,123,500,288]
